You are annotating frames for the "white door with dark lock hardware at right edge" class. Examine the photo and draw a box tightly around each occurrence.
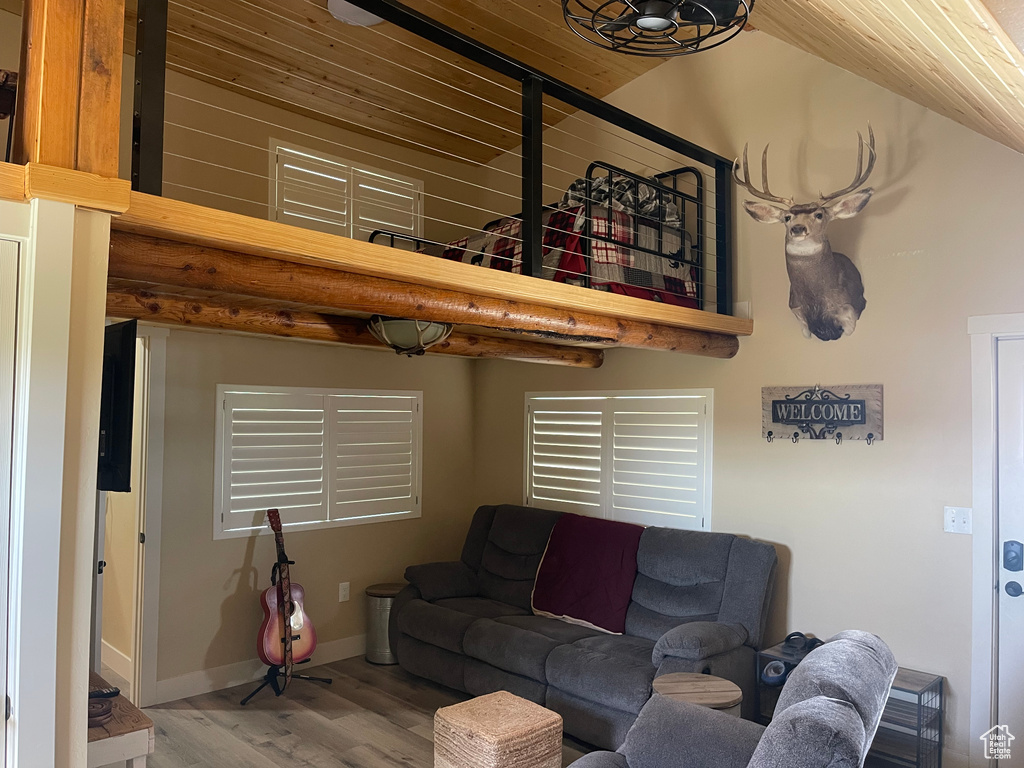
[995,339,1024,745]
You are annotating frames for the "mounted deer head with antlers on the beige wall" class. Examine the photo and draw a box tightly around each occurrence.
[732,126,877,341]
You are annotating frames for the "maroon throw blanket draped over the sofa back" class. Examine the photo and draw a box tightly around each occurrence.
[532,513,643,634]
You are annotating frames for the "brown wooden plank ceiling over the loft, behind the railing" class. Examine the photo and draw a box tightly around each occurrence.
[125,0,660,163]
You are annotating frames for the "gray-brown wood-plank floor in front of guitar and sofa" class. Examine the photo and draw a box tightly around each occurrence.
[145,657,586,768]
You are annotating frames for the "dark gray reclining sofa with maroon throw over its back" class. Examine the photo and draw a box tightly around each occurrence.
[390,505,776,750]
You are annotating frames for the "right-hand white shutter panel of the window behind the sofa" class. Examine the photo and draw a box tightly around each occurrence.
[609,396,708,530]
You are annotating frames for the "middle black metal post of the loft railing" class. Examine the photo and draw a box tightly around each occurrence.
[522,75,544,278]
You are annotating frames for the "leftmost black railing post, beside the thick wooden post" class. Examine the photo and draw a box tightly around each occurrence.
[131,0,167,195]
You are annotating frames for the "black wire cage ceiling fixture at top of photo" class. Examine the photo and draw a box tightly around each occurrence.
[562,0,754,57]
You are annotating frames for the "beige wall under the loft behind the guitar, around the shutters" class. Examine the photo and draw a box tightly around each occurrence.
[157,331,473,680]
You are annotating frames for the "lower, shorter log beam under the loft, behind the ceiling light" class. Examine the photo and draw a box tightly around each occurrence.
[106,289,604,368]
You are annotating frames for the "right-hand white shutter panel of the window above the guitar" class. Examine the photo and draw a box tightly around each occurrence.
[328,392,423,521]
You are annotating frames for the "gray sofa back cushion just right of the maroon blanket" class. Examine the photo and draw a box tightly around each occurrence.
[626,527,735,641]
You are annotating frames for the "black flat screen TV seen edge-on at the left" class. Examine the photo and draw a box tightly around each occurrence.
[96,321,138,493]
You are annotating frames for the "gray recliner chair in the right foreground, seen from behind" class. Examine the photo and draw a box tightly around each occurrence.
[571,631,897,768]
